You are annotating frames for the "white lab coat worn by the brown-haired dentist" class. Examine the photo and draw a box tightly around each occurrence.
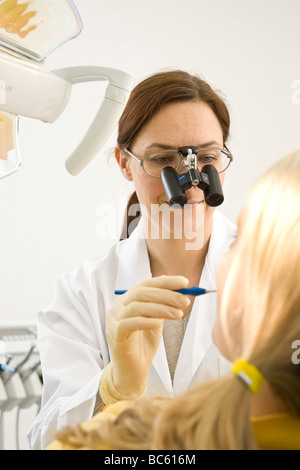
[28,211,236,449]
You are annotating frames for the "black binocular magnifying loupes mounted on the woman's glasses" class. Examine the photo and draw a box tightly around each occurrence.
[161,147,224,207]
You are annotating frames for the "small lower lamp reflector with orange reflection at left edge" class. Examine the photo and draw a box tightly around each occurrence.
[0,111,21,178]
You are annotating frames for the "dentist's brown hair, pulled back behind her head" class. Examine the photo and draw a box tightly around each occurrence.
[117,70,230,239]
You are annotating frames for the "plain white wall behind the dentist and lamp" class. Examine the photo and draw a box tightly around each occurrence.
[0,0,300,325]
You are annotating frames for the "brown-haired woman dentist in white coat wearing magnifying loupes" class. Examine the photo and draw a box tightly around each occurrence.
[29,71,236,449]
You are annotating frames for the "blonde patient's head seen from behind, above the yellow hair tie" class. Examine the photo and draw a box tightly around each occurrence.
[213,151,300,412]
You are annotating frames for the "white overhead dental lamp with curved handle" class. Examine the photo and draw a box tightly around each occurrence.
[0,0,134,178]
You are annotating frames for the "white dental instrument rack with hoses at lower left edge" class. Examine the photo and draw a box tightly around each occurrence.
[0,319,43,451]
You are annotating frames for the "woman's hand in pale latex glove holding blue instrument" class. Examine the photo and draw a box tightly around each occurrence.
[100,276,190,404]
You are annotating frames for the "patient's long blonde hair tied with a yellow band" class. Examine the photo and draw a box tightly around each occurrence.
[55,151,300,450]
